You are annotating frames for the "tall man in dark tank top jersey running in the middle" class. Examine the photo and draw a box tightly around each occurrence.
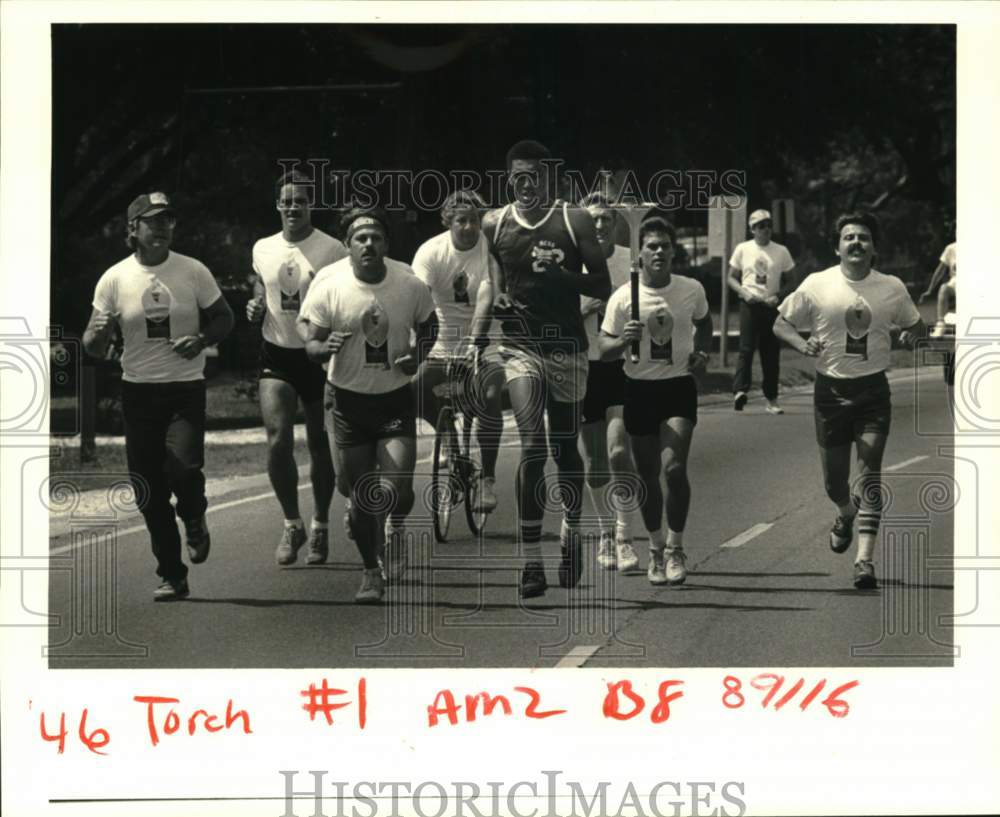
[483,140,611,598]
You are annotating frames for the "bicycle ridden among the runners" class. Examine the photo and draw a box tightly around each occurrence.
[431,344,489,542]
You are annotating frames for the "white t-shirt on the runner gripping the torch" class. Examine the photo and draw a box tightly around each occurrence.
[601,275,708,380]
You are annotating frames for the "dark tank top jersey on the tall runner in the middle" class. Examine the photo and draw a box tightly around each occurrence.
[493,200,587,353]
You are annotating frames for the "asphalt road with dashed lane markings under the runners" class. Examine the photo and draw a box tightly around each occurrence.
[50,370,955,668]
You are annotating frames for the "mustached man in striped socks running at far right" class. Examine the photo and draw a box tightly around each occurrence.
[774,213,927,590]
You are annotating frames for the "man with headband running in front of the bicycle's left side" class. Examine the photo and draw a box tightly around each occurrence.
[302,207,438,604]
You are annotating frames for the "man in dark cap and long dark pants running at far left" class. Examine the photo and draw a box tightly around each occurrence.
[83,192,233,601]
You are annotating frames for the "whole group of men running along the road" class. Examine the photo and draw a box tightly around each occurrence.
[84,140,925,603]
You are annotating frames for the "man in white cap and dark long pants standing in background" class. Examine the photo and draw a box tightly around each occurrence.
[728,210,795,414]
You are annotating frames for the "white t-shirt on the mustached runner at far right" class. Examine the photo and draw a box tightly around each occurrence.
[778,265,920,378]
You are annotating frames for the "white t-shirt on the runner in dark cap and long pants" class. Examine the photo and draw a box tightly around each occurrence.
[94,252,222,383]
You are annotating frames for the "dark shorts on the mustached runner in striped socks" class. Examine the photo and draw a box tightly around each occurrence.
[813,372,892,448]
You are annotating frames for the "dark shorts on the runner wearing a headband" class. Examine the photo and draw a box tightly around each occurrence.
[330,385,417,448]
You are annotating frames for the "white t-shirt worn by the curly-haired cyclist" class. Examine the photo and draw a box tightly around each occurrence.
[413,232,496,357]
